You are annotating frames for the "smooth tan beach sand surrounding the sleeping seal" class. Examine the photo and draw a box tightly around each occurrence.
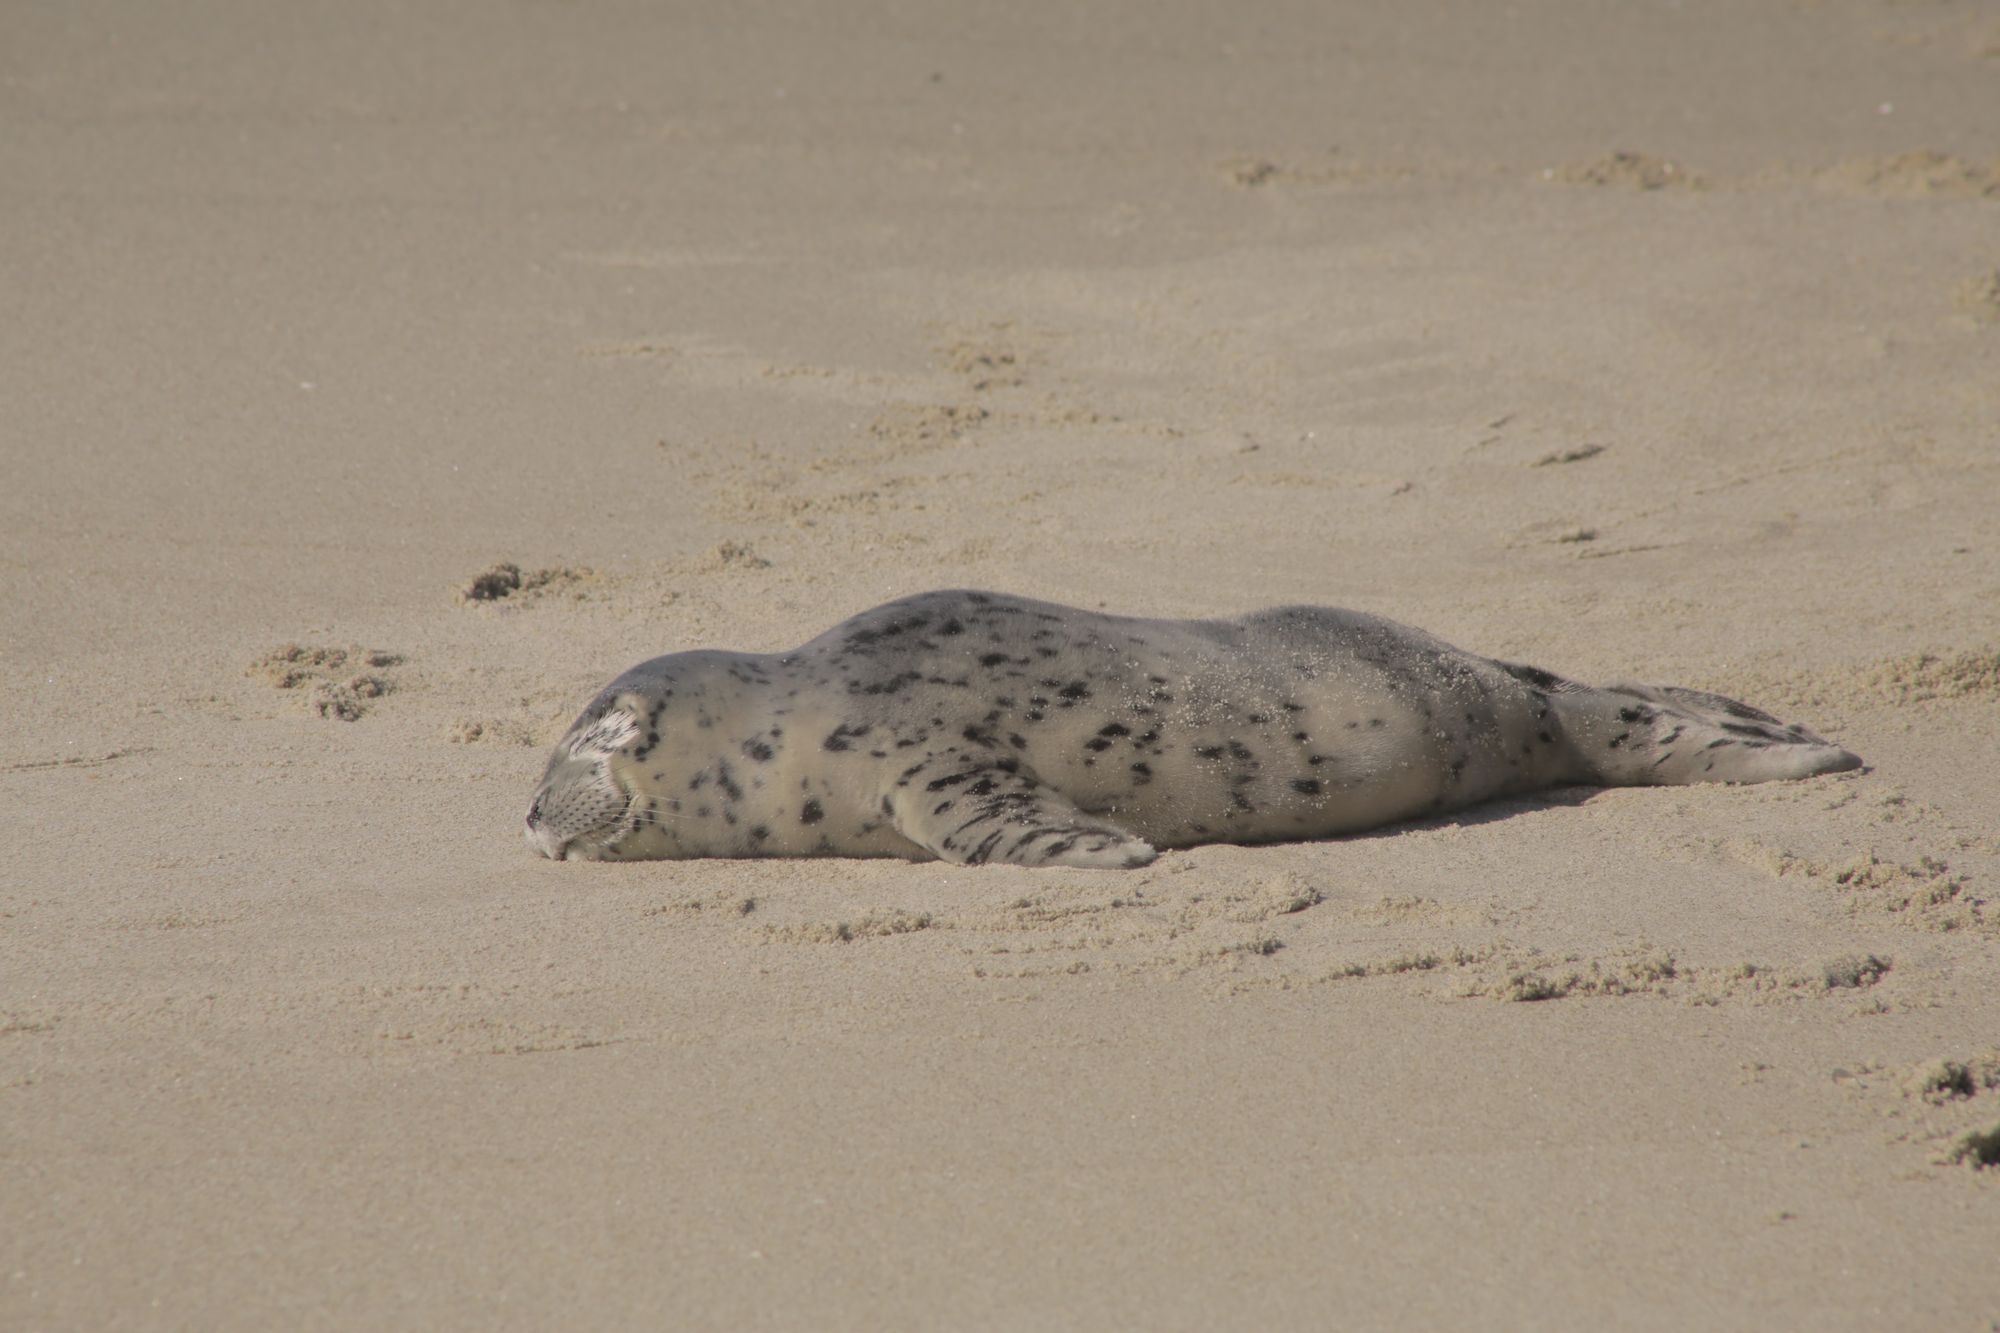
[0,0,2000,1329]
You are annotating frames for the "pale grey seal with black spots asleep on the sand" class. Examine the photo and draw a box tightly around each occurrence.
[528,590,1862,867]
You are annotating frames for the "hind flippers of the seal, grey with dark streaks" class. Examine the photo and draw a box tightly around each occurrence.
[1552,685,1862,787]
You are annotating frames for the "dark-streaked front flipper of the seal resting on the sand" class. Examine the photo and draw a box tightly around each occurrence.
[888,751,1158,871]
